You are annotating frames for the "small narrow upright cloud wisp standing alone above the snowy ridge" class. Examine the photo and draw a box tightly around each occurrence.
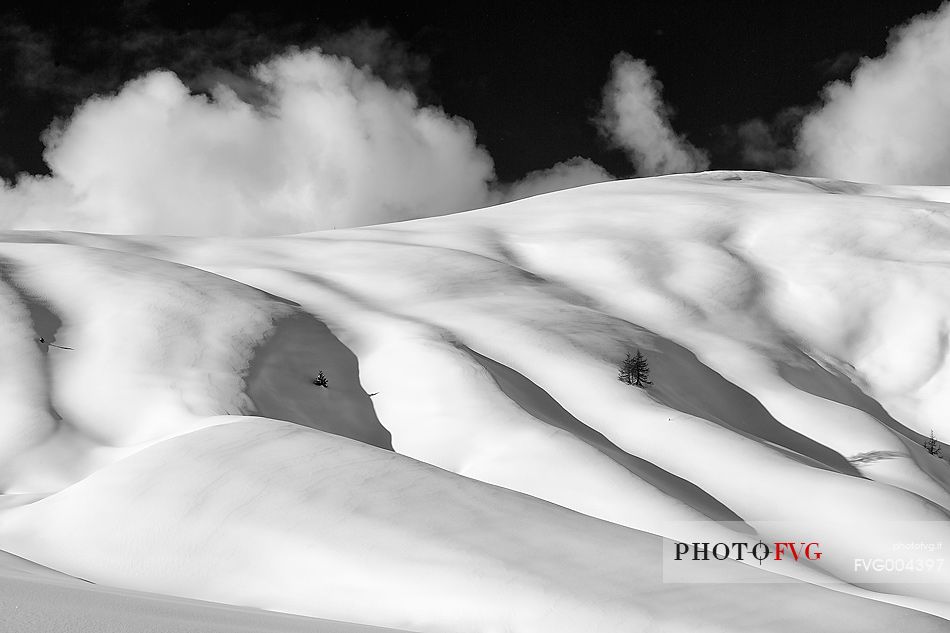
[598,53,709,176]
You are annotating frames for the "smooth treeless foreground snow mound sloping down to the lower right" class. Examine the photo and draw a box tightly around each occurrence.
[0,418,946,633]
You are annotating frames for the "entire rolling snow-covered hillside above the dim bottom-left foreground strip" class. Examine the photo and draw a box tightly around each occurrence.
[0,172,950,631]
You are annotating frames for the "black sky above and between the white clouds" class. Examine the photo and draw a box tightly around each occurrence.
[0,0,939,180]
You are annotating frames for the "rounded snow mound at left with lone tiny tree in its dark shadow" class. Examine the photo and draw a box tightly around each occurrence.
[0,234,391,494]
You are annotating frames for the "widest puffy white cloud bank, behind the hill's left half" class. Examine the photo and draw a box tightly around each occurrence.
[0,40,611,235]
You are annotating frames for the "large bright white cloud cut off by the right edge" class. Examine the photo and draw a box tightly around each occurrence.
[797,4,950,184]
